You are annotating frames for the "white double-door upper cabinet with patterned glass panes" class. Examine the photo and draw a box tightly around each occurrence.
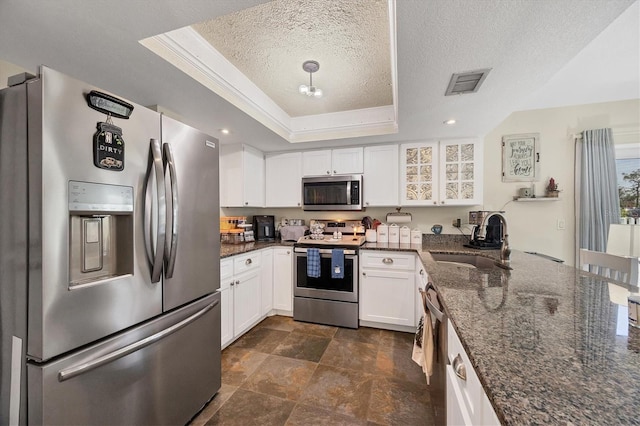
[400,140,482,206]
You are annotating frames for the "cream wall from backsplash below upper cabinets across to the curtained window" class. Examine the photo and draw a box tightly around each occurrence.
[220,99,640,265]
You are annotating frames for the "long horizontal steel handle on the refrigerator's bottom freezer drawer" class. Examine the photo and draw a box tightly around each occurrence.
[58,300,220,382]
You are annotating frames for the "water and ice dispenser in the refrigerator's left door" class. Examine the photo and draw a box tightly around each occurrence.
[68,181,133,289]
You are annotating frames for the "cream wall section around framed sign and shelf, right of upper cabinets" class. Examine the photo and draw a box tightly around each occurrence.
[484,99,640,265]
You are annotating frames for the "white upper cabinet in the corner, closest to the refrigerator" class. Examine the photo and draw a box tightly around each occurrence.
[220,145,265,207]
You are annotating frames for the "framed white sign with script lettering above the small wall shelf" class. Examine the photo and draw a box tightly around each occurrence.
[502,133,540,182]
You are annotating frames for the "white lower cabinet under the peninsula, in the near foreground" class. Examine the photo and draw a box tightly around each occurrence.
[447,321,500,425]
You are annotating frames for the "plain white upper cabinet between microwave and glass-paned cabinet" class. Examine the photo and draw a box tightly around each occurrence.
[362,145,400,207]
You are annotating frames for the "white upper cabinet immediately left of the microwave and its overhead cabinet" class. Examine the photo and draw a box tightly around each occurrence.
[265,152,302,207]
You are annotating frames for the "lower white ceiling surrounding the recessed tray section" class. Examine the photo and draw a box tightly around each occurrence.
[0,0,640,152]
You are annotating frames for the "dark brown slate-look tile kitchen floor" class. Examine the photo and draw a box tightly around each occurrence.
[191,316,433,426]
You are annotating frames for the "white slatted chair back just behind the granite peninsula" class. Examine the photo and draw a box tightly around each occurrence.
[580,249,639,286]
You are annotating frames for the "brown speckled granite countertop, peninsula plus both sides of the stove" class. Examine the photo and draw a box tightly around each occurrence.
[221,235,640,425]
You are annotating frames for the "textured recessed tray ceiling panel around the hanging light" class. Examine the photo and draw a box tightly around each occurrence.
[192,0,393,117]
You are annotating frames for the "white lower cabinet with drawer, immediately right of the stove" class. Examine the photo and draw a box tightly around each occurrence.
[359,250,417,327]
